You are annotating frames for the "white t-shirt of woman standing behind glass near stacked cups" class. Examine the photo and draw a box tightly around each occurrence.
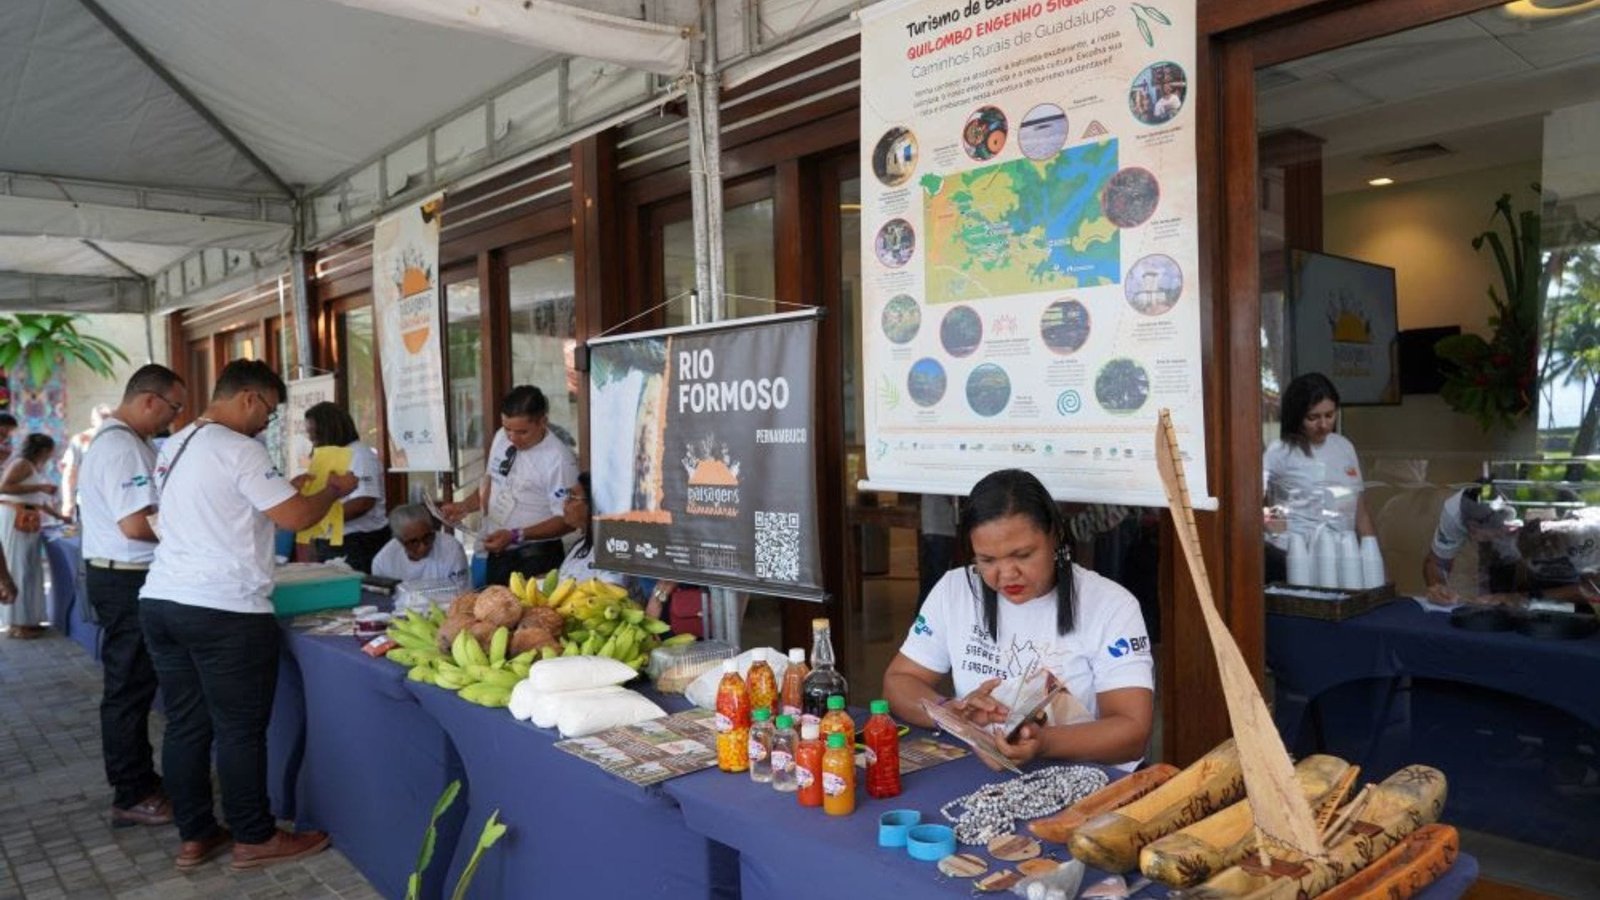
[1261,434,1363,549]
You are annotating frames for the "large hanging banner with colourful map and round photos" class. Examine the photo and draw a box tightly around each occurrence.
[861,0,1214,506]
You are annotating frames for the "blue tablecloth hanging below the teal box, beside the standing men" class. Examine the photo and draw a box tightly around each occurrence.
[280,628,467,897]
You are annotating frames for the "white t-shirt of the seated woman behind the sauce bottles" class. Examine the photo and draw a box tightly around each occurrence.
[901,565,1155,759]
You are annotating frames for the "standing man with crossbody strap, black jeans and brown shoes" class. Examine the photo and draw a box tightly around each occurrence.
[139,360,357,870]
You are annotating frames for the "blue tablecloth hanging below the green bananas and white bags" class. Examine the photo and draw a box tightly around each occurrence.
[406,682,739,898]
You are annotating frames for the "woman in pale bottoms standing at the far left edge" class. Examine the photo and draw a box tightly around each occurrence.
[0,434,62,639]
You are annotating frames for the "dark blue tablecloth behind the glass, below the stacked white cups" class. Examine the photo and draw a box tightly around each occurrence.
[1267,599,1600,738]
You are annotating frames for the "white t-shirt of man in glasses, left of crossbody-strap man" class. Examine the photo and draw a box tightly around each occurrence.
[78,418,155,564]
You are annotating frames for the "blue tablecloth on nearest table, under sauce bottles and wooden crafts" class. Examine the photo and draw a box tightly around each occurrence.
[666,739,1477,900]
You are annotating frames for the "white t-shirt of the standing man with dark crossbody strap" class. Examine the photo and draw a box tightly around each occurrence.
[139,423,296,613]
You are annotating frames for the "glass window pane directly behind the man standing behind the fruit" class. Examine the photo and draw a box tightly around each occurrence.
[509,253,581,452]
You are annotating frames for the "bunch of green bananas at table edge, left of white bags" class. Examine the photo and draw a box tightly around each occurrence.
[386,610,538,706]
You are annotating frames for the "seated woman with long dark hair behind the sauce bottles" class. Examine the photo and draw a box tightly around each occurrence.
[883,469,1155,769]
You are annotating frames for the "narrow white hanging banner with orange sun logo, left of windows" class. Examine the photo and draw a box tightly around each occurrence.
[373,194,450,472]
